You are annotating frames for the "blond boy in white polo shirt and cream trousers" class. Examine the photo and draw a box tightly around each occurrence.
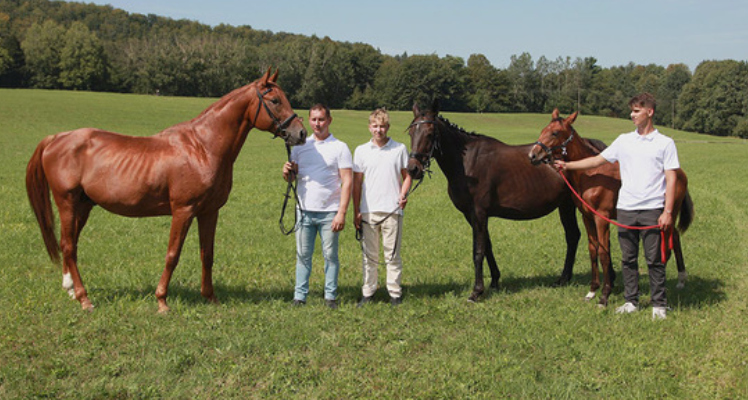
[353,108,411,306]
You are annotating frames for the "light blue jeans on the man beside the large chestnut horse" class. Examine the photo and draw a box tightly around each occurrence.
[294,211,340,301]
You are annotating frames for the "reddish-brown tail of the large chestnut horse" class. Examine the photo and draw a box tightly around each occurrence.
[26,136,60,263]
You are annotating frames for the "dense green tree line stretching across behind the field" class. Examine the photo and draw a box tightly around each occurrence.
[0,0,748,138]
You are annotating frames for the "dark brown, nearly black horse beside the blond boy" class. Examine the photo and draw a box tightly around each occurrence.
[408,102,581,301]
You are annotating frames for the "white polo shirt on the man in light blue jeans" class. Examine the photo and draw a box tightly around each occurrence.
[291,134,353,212]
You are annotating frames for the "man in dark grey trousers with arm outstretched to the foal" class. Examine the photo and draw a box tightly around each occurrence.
[556,93,680,319]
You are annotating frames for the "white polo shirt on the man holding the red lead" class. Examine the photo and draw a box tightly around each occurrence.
[600,130,680,210]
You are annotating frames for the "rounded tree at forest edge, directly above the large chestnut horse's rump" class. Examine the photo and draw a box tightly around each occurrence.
[59,22,108,90]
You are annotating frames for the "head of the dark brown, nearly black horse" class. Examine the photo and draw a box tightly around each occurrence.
[408,100,439,179]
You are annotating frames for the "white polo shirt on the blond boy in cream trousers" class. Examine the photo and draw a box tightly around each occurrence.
[353,138,408,214]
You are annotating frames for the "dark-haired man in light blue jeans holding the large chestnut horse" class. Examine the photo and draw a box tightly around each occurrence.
[283,104,353,309]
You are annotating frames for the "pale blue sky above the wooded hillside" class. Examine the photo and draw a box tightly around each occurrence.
[83,0,748,71]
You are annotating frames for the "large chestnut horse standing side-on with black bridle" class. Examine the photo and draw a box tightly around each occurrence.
[26,69,306,312]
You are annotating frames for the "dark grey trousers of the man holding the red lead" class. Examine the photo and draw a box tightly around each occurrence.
[618,208,667,307]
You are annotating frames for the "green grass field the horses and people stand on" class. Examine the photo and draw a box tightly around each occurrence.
[0,90,748,399]
